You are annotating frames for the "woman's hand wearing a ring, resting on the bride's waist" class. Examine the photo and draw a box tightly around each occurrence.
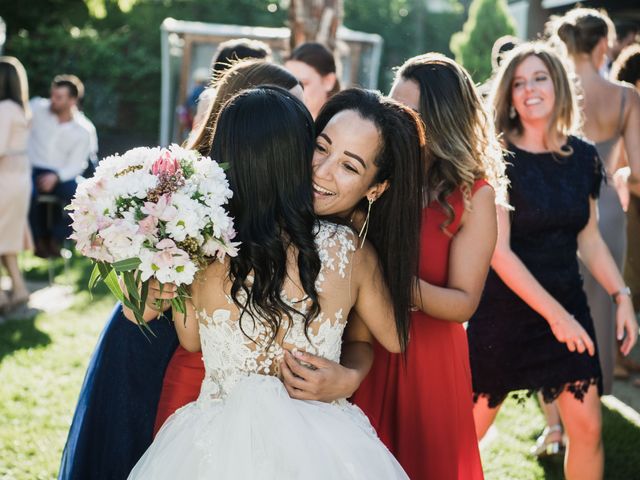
[281,350,361,402]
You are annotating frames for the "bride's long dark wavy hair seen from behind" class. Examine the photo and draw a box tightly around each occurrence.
[210,86,320,348]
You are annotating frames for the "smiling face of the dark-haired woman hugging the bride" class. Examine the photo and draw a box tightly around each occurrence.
[313,110,381,218]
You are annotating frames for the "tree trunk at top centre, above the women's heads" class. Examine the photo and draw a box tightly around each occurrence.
[289,0,344,51]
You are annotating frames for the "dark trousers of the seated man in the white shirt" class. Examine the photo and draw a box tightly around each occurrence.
[29,167,78,244]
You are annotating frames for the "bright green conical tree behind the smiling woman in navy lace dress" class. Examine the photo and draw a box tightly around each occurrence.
[451,0,516,82]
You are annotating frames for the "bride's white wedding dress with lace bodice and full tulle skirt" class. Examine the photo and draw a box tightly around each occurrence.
[129,223,408,480]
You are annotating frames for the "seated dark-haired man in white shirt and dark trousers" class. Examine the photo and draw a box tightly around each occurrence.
[27,75,97,257]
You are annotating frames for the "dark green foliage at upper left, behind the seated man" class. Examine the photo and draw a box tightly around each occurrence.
[0,0,286,136]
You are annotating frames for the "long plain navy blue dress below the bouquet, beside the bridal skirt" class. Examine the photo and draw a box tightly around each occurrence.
[58,304,178,480]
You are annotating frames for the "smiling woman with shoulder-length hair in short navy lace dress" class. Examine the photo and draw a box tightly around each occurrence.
[467,44,638,480]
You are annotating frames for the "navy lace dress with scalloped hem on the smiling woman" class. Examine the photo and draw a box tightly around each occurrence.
[467,137,603,407]
